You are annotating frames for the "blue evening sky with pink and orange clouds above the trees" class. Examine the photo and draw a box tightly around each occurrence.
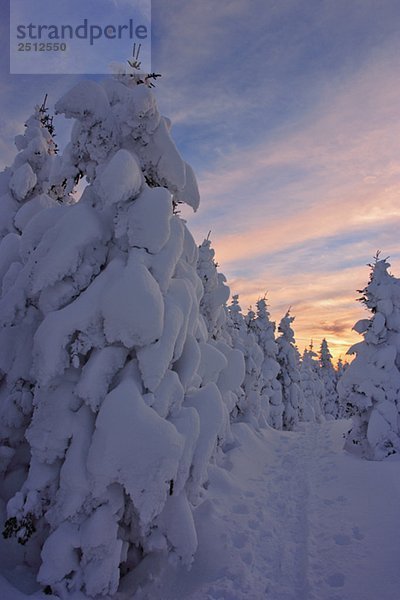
[0,0,400,357]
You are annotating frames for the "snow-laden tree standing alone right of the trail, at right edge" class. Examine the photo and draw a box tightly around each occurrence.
[338,254,400,460]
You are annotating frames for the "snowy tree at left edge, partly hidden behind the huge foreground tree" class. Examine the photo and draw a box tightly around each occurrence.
[0,102,62,516]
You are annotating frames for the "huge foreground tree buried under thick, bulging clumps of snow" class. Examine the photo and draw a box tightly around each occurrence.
[0,76,231,597]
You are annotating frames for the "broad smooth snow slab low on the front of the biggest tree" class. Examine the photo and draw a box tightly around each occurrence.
[88,379,184,526]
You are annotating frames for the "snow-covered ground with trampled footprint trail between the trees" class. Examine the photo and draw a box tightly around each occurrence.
[134,422,400,600]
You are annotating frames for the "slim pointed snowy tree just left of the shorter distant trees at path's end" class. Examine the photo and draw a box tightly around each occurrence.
[276,311,304,430]
